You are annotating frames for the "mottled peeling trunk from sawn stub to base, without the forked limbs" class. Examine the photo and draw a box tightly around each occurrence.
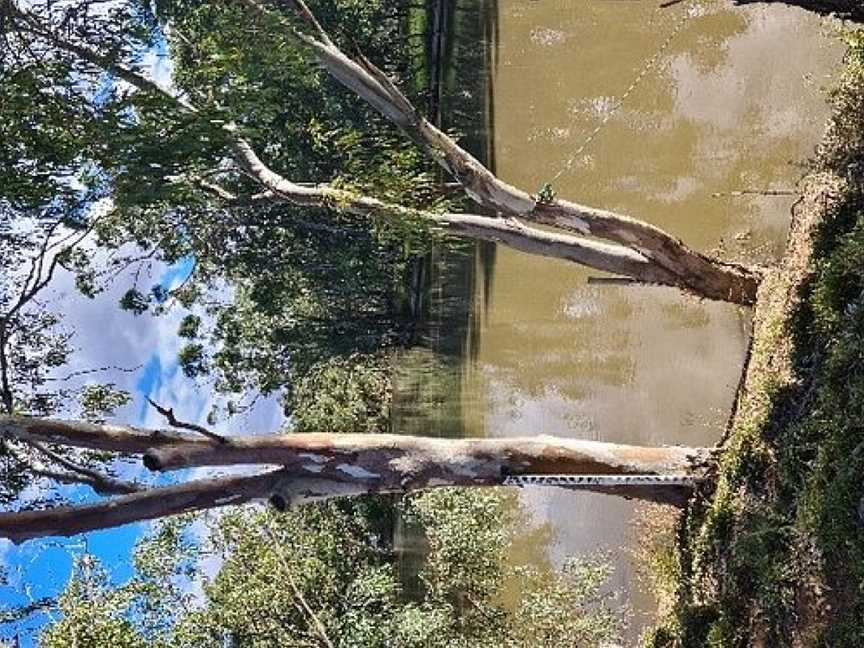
[144,433,706,480]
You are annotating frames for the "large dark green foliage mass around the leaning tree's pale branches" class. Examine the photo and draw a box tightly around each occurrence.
[0,0,460,420]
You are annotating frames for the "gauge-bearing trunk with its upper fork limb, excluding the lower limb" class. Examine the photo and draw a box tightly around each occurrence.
[0,416,708,487]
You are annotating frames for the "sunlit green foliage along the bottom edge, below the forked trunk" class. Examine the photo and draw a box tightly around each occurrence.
[41,489,621,648]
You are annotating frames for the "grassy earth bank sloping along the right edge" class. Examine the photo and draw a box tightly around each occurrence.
[648,33,864,648]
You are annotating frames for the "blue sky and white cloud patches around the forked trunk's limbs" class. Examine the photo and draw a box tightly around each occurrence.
[0,252,290,646]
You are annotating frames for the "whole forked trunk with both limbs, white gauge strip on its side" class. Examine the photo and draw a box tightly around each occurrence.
[0,416,709,542]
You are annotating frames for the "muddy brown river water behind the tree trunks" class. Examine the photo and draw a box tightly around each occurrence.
[393,0,842,632]
